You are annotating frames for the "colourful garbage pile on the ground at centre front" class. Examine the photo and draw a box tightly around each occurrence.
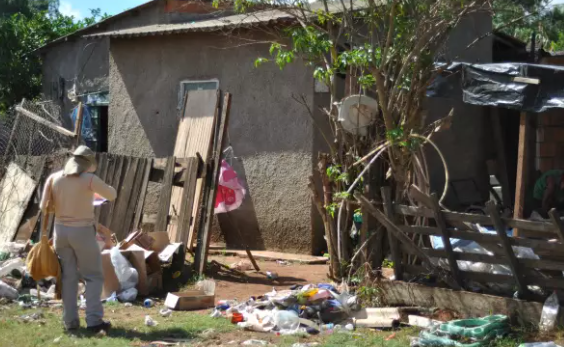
[211,283,360,335]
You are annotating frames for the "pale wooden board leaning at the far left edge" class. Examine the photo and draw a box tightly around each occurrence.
[0,163,37,245]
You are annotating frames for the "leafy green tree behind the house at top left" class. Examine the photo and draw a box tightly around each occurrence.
[0,0,107,114]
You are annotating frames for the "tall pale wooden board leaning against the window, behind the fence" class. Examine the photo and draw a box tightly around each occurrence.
[168,90,218,248]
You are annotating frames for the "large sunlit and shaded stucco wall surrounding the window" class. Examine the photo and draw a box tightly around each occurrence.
[109,33,315,253]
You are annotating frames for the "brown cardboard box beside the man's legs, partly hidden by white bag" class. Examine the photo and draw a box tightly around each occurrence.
[102,250,149,298]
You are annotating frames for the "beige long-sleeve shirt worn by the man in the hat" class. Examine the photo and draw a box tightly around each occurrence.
[41,171,117,227]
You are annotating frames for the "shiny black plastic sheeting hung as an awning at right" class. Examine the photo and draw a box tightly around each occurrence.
[427,63,564,113]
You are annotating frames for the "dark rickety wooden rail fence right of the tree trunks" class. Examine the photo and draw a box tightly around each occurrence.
[356,187,564,298]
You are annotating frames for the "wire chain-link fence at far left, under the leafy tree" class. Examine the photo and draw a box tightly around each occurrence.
[0,100,72,178]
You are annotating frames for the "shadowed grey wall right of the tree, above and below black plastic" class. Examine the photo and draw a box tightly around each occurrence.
[425,13,493,209]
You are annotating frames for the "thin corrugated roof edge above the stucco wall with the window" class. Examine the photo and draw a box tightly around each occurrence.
[84,10,295,38]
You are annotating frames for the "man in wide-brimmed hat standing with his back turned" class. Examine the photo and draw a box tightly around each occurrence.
[41,146,117,332]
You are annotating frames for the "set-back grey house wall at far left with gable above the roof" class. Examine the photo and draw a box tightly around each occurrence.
[39,0,231,125]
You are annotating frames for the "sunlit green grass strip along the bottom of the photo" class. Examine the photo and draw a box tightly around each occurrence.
[0,303,562,347]
